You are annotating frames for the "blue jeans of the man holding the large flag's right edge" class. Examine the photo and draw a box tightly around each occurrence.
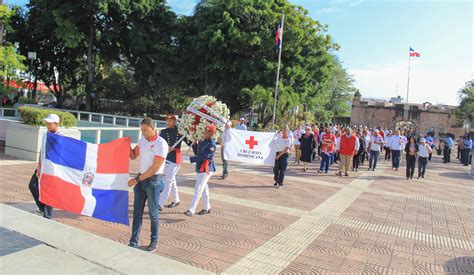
[130,175,164,246]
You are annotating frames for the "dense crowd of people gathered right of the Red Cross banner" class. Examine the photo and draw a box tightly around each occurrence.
[274,124,473,187]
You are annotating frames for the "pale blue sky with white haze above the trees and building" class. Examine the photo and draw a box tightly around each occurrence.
[7,0,474,105]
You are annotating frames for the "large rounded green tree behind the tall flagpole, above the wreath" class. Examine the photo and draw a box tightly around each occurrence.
[178,0,338,116]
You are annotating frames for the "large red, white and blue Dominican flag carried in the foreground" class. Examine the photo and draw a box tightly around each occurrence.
[39,133,130,225]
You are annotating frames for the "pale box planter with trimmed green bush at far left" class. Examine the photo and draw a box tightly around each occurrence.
[5,106,81,161]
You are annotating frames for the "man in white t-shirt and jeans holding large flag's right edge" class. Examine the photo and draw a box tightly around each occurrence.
[128,118,169,252]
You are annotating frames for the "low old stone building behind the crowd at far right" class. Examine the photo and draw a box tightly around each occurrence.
[351,92,464,136]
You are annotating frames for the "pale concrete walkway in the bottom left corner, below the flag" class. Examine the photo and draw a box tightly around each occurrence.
[0,204,210,274]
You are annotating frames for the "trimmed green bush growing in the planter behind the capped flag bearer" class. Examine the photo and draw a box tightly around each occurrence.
[18,106,77,128]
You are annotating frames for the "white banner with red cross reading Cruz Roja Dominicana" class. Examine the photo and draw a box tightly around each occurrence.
[222,129,277,165]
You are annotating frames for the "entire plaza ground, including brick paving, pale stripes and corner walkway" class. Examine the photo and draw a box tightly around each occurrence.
[0,148,474,274]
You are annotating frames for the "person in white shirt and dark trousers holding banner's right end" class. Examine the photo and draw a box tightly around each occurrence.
[273,129,291,188]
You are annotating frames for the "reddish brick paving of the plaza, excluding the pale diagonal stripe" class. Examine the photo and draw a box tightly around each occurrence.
[0,152,474,274]
